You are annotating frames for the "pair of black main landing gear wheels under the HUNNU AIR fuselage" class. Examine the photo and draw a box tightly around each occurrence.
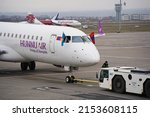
[20,61,36,71]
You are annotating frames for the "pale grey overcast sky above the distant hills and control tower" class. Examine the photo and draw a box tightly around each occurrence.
[0,0,150,12]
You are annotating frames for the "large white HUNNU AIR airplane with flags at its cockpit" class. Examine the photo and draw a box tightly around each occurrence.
[0,22,100,82]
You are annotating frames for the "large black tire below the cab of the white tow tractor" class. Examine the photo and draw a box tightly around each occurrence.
[112,76,125,93]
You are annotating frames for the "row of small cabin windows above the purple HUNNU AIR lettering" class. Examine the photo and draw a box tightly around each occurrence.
[0,32,43,40]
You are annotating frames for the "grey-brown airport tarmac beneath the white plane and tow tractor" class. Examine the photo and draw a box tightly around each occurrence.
[0,32,150,100]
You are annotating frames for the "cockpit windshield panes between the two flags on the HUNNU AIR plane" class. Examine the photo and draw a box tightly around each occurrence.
[72,36,90,43]
